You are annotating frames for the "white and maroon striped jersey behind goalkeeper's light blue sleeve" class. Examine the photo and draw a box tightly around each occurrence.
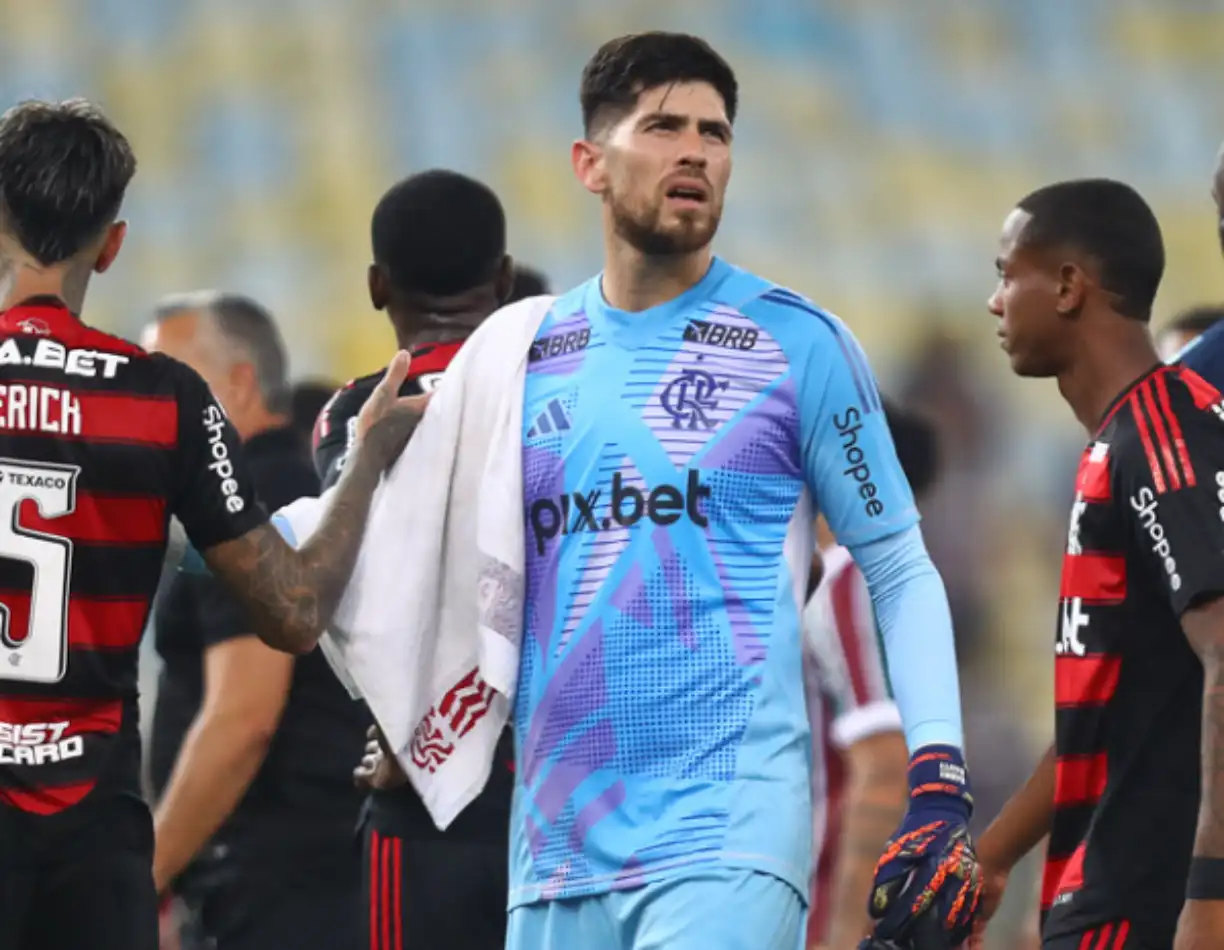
[803,547,901,943]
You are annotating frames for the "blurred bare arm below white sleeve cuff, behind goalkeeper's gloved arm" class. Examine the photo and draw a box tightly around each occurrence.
[829,730,909,950]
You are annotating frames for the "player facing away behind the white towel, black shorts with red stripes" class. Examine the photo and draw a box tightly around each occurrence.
[315,169,521,950]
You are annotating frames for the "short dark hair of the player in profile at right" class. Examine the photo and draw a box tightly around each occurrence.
[1016,179,1164,323]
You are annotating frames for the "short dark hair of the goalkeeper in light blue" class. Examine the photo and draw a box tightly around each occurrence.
[579,32,739,136]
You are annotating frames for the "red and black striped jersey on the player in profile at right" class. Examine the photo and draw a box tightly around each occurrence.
[1042,366,1224,946]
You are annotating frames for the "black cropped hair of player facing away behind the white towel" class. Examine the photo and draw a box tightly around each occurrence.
[370,169,506,296]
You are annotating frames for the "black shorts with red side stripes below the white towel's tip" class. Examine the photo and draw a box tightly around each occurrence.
[361,821,509,950]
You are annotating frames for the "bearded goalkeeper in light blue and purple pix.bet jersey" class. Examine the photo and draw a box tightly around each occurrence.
[508,27,979,950]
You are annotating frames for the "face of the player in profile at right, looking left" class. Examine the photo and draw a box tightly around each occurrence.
[987,208,1082,377]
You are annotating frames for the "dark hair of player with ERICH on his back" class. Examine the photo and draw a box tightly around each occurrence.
[0,99,136,267]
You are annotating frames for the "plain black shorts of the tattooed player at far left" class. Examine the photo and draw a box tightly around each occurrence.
[0,797,158,950]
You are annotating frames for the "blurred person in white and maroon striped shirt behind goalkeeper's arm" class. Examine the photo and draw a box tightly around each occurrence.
[803,399,939,950]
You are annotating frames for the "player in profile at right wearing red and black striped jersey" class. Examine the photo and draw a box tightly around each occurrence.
[978,180,1224,950]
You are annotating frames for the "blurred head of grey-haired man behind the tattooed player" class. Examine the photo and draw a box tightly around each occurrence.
[141,291,291,438]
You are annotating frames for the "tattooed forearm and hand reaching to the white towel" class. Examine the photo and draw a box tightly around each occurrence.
[202,354,427,654]
